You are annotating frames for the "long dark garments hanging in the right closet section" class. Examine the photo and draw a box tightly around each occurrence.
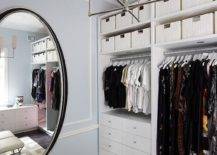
[157,53,217,155]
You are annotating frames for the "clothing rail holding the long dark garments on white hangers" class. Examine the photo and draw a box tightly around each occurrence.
[164,47,217,56]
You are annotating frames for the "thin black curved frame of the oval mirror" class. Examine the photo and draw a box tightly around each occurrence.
[0,8,68,155]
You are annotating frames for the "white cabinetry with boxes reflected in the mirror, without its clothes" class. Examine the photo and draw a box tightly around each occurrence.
[32,36,59,134]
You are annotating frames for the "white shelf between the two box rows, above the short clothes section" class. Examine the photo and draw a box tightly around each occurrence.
[100,20,151,37]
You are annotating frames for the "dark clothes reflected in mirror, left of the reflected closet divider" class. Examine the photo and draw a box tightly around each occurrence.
[31,69,46,103]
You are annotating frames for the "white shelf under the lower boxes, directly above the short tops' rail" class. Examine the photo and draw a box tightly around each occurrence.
[100,46,151,55]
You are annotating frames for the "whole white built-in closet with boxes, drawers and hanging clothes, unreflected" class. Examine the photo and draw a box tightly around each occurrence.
[98,0,217,155]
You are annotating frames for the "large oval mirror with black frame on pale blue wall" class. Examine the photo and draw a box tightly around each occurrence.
[0,9,67,155]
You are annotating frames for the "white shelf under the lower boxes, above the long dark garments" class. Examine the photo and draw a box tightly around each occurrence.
[155,34,217,50]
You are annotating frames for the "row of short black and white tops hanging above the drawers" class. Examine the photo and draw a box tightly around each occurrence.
[103,60,151,115]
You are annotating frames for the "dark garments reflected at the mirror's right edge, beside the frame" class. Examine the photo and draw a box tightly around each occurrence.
[50,70,61,110]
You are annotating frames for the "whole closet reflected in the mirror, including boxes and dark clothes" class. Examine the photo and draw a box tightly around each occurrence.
[31,36,61,134]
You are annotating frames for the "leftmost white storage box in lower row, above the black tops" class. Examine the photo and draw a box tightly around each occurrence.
[102,37,115,53]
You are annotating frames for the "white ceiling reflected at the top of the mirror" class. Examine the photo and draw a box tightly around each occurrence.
[0,12,47,33]
